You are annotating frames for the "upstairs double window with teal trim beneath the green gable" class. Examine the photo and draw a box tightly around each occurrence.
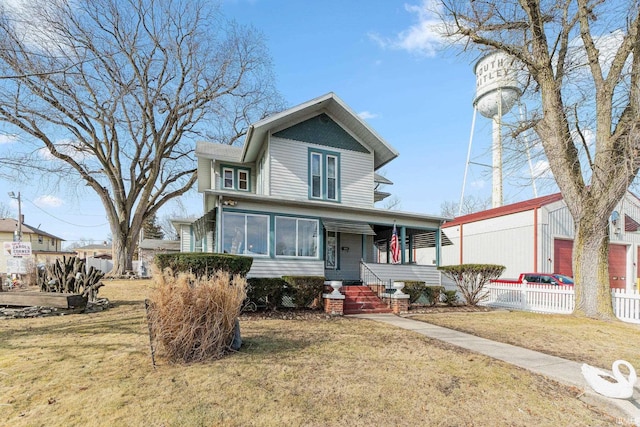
[309,149,340,202]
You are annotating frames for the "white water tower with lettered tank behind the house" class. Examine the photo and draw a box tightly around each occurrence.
[473,52,522,208]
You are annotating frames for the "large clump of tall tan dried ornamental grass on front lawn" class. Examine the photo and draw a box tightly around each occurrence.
[148,270,247,363]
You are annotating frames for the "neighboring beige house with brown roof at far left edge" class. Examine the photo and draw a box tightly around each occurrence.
[0,218,73,273]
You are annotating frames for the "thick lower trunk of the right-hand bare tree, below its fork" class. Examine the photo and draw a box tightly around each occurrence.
[573,215,616,320]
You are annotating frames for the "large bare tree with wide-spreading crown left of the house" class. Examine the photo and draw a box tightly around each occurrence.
[0,0,281,274]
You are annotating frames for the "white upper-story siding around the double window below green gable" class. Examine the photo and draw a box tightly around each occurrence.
[269,138,373,208]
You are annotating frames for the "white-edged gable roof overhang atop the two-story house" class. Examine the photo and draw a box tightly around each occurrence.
[241,92,398,169]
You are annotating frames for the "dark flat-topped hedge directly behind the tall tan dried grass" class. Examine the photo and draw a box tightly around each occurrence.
[154,252,253,277]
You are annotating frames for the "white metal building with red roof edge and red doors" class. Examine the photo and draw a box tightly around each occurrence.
[441,192,640,290]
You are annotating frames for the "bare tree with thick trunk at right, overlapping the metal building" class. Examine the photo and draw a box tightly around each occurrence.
[439,0,640,319]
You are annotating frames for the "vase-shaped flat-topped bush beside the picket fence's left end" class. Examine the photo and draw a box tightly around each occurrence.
[438,264,506,305]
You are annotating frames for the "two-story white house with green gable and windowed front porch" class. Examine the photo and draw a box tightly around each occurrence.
[173,93,444,283]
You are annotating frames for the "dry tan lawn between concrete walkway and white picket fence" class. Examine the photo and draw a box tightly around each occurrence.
[412,310,640,369]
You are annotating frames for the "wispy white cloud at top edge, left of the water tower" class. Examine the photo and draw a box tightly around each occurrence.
[369,0,444,56]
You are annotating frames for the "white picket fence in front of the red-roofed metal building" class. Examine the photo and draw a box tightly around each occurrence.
[479,283,640,323]
